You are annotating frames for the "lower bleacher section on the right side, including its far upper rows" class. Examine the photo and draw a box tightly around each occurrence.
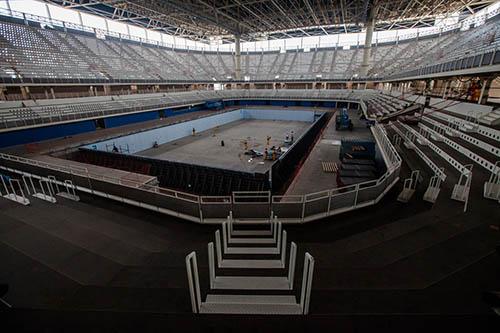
[378,90,500,202]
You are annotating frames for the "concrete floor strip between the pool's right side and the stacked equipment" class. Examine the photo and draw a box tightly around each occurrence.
[286,110,373,195]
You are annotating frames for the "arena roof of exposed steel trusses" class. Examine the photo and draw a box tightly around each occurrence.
[45,0,495,41]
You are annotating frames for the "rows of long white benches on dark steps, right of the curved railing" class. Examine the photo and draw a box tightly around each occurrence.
[388,92,500,202]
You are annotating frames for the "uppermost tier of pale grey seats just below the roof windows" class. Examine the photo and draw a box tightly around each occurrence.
[0,14,500,83]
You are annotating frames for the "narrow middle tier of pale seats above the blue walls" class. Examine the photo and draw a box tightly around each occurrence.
[0,89,373,131]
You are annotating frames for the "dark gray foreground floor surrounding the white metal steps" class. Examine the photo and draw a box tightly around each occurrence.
[0,109,500,332]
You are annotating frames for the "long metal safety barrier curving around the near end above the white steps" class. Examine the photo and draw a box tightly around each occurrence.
[0,125,401,223]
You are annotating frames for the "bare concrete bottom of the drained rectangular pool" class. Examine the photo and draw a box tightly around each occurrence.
[137,120,312,173]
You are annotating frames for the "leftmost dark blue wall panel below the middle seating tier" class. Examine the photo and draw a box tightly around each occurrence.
[0,120,95,147]
